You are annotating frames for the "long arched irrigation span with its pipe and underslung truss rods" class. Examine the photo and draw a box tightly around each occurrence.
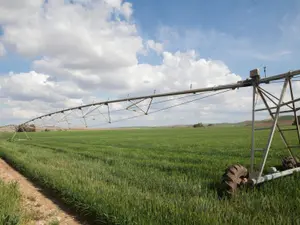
[9,70,300,129]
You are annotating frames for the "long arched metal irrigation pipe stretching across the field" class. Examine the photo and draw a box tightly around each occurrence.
[21,70,300,125]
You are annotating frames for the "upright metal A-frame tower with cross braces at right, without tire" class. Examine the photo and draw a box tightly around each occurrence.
[250,70,300,184]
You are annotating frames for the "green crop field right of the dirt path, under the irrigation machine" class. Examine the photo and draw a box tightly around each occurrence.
[0,127,300,225]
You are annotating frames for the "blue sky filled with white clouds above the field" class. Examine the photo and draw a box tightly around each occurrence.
[0,0,300,126]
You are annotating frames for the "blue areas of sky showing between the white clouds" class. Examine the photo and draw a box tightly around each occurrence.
[0,0,300,77]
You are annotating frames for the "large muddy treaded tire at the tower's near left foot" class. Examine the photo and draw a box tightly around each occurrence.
[220,164,249,196]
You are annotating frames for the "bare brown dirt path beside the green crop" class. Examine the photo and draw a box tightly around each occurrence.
[0,159,82,225]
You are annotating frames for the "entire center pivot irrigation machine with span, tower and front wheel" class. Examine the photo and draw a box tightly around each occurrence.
[6,69,300,195]
